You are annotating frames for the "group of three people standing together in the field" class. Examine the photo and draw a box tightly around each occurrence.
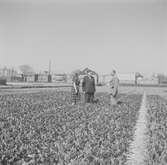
[71,70,119,105]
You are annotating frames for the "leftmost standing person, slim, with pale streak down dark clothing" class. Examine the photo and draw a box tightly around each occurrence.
[71,73,80,105]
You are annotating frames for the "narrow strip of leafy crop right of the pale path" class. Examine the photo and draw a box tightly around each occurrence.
[146,96,167,165]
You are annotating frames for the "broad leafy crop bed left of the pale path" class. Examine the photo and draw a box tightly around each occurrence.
[0,90,141,164]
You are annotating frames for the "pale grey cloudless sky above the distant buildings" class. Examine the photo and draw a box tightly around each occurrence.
[0,0,167,74]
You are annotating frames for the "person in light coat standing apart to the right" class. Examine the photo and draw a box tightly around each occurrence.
[109,70,119,105]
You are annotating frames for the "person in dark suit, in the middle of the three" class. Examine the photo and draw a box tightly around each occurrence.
[82,71,96,103]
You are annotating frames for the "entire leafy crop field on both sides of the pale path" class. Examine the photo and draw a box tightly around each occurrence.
[0,89,167,165]
